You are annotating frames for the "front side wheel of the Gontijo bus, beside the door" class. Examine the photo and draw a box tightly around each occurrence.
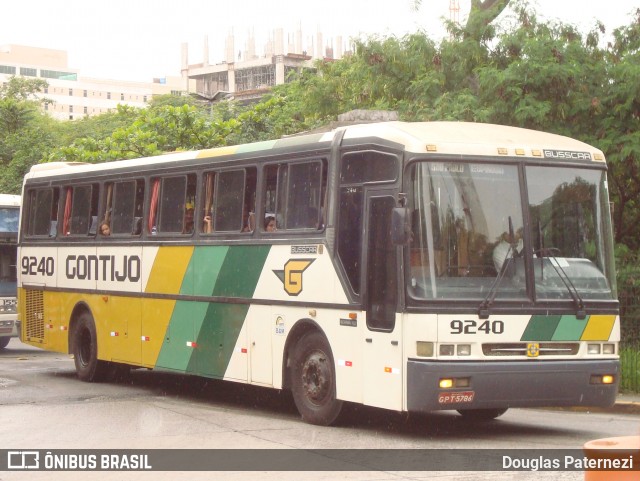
[291,331,342,426]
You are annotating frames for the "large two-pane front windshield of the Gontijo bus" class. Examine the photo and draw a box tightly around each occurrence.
[409,162,615,300]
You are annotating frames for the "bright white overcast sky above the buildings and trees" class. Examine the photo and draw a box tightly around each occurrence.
[0,0,640,82]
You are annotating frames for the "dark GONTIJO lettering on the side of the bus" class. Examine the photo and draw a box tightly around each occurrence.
[65,255,141,282]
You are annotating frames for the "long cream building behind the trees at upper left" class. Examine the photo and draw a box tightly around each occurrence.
[0,45,190,120]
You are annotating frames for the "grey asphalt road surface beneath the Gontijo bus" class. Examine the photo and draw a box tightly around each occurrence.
[0,339,640,481]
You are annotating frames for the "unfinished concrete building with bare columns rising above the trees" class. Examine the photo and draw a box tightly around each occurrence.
[181,29,344,102]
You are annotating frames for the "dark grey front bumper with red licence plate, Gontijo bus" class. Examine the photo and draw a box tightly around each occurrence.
[407,359,620,412]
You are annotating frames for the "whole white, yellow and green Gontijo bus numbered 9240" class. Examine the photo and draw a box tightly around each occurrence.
[18,122,620,424]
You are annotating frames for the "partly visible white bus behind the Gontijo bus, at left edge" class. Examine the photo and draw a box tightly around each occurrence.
[0,194,20,349]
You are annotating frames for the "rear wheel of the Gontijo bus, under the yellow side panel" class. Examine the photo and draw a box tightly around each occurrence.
[73,312,109,382]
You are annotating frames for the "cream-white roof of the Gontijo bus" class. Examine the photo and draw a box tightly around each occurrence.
[26,121,605,178]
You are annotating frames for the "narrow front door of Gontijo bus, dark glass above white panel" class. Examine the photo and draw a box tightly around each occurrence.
[363,191,402,410]
